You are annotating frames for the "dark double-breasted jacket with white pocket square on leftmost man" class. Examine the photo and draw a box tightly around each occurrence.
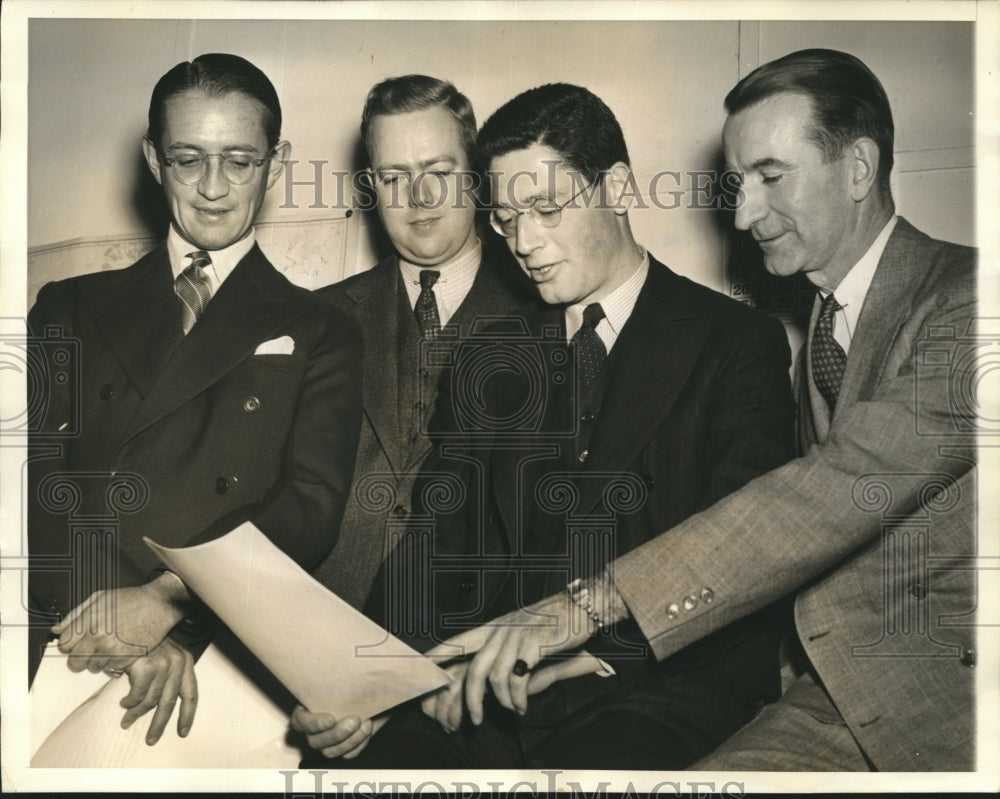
[29,245,361,676]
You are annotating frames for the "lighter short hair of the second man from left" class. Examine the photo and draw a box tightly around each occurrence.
[361,75,478,168]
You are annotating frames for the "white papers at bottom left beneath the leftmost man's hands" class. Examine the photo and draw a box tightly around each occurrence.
[29,634,309,768]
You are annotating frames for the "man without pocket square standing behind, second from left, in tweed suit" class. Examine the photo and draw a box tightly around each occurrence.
[316,75,531,608]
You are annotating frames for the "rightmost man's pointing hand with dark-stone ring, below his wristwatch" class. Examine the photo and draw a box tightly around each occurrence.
[426,594,627,724]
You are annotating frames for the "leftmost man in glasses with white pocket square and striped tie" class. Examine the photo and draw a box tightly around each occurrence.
[29,54,361,744]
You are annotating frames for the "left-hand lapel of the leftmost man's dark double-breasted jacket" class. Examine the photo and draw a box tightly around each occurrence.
[80,243,183,397]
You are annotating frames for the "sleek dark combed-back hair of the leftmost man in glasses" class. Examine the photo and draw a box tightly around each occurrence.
[146,53,281,147]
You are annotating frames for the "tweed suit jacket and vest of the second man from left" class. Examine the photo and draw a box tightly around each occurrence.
[315,244,532,608]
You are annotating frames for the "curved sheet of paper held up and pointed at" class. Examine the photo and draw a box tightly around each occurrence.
[145,522,448,719]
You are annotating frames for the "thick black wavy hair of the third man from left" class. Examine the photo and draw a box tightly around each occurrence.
[479,83,629,182]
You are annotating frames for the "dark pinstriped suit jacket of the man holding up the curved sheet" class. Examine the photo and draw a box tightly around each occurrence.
[368,259,794,733]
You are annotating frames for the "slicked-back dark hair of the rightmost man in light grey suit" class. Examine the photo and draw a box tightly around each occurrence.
[725,49,893,194]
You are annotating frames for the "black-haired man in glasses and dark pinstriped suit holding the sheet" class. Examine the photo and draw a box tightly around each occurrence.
[293,84,793,769]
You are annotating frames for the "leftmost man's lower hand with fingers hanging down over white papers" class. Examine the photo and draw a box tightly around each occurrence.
[121,638,198,746]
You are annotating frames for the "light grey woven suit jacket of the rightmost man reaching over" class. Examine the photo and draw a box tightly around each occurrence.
[614,219,977,771]
